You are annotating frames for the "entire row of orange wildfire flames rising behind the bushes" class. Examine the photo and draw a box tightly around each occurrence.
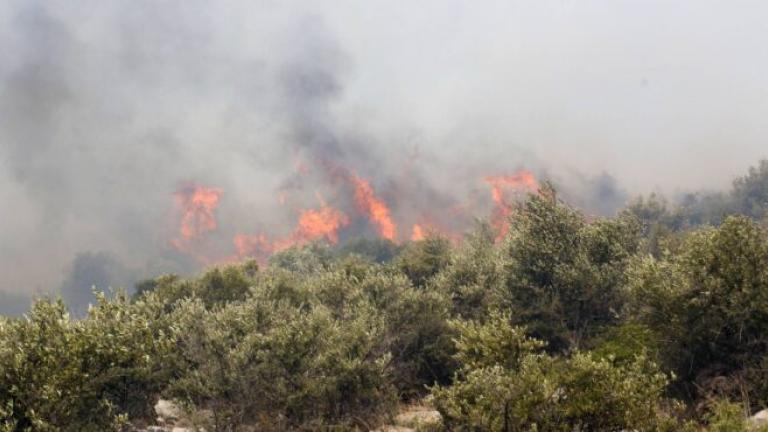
[171,162,539,263]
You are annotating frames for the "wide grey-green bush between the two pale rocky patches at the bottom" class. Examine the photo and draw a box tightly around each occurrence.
[169,299,394,430]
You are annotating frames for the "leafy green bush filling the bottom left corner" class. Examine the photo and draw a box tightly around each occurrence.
[0,294,171,431]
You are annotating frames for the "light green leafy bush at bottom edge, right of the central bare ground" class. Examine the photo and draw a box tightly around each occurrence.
[433,315,676,431]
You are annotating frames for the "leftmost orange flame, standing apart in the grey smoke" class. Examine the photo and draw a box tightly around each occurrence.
[171,184,222,251]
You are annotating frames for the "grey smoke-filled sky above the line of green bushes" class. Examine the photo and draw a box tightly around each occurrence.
[0,0,768,310]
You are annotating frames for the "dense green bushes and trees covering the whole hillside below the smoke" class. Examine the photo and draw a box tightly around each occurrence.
[0,162,768,431]
